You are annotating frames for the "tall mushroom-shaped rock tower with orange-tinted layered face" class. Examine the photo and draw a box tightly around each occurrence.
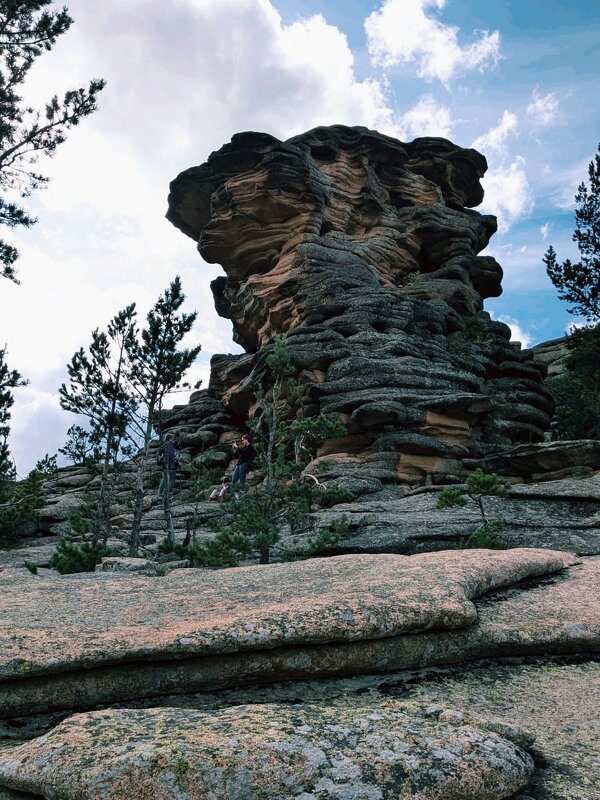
[167,126,552,482]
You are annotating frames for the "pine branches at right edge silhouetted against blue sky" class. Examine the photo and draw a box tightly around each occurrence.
[543,145,600,324]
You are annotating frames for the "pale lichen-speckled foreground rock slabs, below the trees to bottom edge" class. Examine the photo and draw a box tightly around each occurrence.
[0,549,600,800]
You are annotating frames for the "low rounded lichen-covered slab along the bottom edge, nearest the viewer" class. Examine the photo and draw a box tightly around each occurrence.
[0,699,534,800]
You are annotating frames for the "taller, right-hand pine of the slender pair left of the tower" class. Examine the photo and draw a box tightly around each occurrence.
[129,277,200,556]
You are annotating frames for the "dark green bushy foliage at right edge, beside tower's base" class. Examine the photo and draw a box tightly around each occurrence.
[545,325,600,439]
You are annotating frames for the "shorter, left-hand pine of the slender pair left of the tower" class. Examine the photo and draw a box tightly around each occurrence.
[59,304,137,542]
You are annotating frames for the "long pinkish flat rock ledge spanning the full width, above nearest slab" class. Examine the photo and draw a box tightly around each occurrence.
[0,550,600,718]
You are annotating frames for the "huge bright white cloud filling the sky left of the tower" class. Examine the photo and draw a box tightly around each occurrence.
[0,0,408,471]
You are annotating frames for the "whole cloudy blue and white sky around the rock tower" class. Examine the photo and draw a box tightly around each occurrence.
[0,0,600,475]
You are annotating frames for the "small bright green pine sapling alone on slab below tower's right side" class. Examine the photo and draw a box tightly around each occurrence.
[436,469,510,550]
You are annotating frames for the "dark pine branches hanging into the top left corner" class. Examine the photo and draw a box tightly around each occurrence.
[0,0,104,282]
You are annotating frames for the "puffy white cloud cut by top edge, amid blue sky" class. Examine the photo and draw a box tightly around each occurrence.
[365,0,500,85]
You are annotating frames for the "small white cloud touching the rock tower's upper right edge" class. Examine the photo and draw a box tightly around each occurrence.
[479,157,533,233]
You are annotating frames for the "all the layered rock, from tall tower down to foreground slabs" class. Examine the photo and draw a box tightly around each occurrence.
[0,126,600,800]
